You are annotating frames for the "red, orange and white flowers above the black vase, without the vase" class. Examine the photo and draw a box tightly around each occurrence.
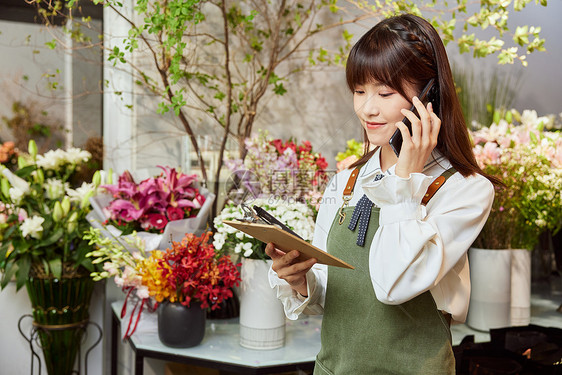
[84,228,241,338]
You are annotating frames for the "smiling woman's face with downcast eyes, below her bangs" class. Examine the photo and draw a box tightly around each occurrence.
[353,81,416,146]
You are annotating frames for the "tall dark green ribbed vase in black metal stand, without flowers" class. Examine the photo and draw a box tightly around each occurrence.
[26,264,94,375]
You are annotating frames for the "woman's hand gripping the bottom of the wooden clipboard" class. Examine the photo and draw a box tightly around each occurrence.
[265,242,316,297]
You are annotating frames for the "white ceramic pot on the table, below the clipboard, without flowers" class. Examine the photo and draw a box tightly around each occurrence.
[239,258,285,350]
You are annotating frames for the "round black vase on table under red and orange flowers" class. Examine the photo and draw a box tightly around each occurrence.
[158,301,207,348]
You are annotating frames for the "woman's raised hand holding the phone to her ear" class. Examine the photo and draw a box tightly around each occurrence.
[395,97,441,178]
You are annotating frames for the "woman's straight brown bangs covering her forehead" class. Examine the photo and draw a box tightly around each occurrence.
[346,26,416,95]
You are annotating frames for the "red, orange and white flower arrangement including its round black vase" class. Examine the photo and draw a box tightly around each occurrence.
[86,228,240,348]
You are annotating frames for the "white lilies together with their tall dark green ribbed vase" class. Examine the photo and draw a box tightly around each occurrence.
[0,141,101,375]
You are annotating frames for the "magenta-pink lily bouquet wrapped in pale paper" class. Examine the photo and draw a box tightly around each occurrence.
[89,166,215,250]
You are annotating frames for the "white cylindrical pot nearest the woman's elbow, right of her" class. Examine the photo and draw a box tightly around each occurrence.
[466,247,511,331]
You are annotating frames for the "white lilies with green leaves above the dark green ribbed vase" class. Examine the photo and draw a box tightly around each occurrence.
[0,141,104,289]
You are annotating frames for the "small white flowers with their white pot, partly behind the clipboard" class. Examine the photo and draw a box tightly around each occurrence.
[213,196,314,349]
